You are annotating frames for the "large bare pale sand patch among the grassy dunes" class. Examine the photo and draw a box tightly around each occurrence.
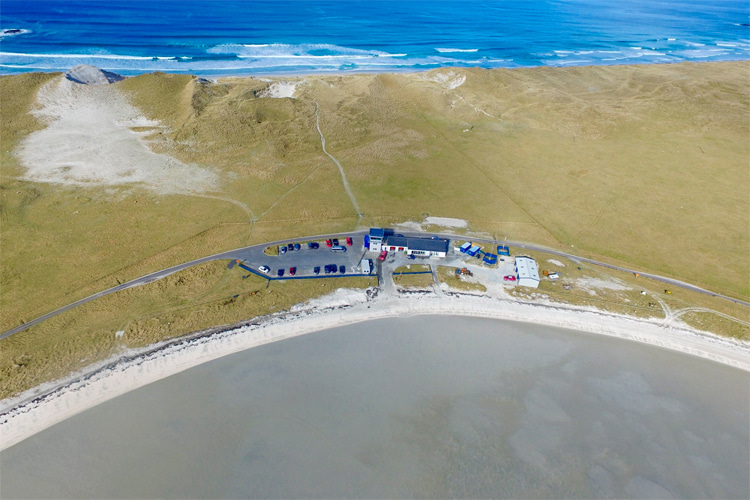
[18,77,218,194]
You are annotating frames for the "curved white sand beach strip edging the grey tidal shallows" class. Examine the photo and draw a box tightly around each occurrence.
[0,290,750,450]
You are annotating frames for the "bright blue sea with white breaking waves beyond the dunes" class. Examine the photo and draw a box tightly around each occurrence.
[0,0,750,75]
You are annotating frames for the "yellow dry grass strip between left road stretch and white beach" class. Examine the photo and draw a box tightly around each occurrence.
[0,261,377,398]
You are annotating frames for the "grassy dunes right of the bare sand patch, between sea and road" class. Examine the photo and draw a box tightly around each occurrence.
[116,62,750,297]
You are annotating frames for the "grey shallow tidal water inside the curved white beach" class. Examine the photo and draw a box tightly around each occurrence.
[0,316,750,498]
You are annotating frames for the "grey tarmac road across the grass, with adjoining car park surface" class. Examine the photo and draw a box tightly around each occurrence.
[0,231,750,340]
